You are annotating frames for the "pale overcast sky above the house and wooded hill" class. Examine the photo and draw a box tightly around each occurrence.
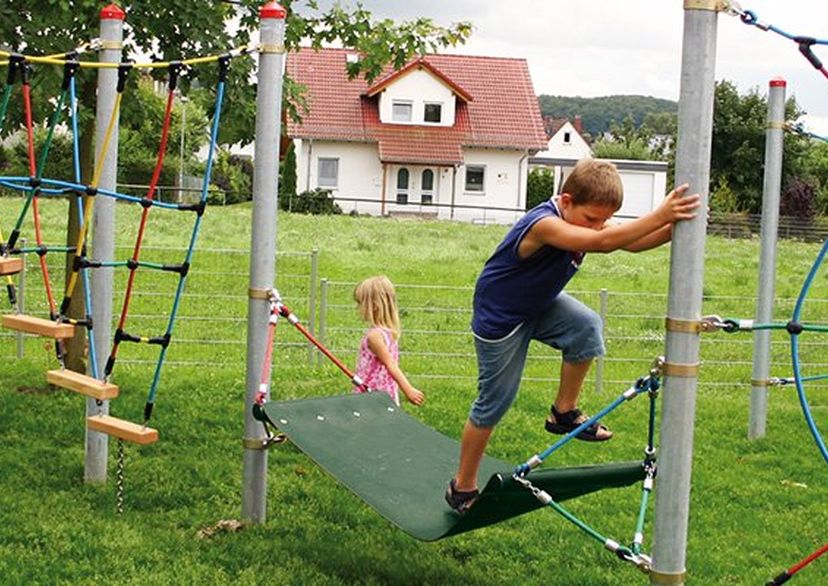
[316,0,828,134]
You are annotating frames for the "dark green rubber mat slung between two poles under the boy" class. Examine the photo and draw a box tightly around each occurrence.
[264,393,644,541]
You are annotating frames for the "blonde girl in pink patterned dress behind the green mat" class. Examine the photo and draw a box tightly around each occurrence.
[354,276,425,405]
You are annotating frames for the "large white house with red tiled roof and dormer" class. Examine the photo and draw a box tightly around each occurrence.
[287,49,547,223]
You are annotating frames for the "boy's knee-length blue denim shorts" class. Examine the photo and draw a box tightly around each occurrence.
[469,292,604,427]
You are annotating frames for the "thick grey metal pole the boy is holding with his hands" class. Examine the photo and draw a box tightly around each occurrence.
[650,5,719,585]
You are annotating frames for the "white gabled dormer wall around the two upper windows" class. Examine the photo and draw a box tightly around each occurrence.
[379,69,455,126]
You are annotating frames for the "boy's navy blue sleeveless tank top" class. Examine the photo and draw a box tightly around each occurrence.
[472,200,584,340]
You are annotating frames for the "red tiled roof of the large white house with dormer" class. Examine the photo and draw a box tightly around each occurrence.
[287,49,547,164]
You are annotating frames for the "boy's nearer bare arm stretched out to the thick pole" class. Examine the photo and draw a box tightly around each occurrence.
[524,184,699,252]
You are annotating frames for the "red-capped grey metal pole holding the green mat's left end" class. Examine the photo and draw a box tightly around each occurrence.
[242,2,287,523]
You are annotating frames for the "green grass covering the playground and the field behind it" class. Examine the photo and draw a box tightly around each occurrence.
[0,198,828,585]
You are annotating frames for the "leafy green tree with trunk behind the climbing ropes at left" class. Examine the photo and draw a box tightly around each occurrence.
[0,0,471,371]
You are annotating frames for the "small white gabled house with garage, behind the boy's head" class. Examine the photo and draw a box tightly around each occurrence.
[529,117,667,219]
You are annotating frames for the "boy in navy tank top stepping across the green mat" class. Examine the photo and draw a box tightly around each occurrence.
[446,159,699,513]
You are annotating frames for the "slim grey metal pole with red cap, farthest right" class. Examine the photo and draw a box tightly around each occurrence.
[748,78,787,439]
